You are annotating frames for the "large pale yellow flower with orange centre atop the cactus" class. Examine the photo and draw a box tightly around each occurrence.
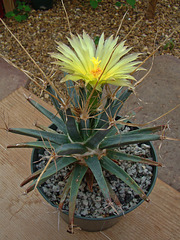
[51,32,140,91]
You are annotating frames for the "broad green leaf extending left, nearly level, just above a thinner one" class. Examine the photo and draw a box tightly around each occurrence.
[9,128,69,144]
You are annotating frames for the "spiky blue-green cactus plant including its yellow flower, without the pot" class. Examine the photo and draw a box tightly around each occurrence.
[9,32,165,233]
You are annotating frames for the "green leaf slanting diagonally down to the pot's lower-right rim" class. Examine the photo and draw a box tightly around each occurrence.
[101,157,149,201]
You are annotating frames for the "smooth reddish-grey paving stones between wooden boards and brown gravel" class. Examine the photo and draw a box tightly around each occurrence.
[0,55,180,191]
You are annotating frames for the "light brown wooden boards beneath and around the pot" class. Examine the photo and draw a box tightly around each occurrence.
[0,88,180,240]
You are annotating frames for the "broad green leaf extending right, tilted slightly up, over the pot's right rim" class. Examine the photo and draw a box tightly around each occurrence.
[99,134,161,149]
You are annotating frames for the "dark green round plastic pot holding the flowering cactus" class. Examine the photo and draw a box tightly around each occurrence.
[31,126,157,232]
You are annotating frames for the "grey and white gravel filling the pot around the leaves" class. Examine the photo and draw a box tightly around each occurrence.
[35,127,153,218]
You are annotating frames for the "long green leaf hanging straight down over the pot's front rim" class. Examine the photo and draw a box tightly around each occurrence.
[69,164,88,229]
